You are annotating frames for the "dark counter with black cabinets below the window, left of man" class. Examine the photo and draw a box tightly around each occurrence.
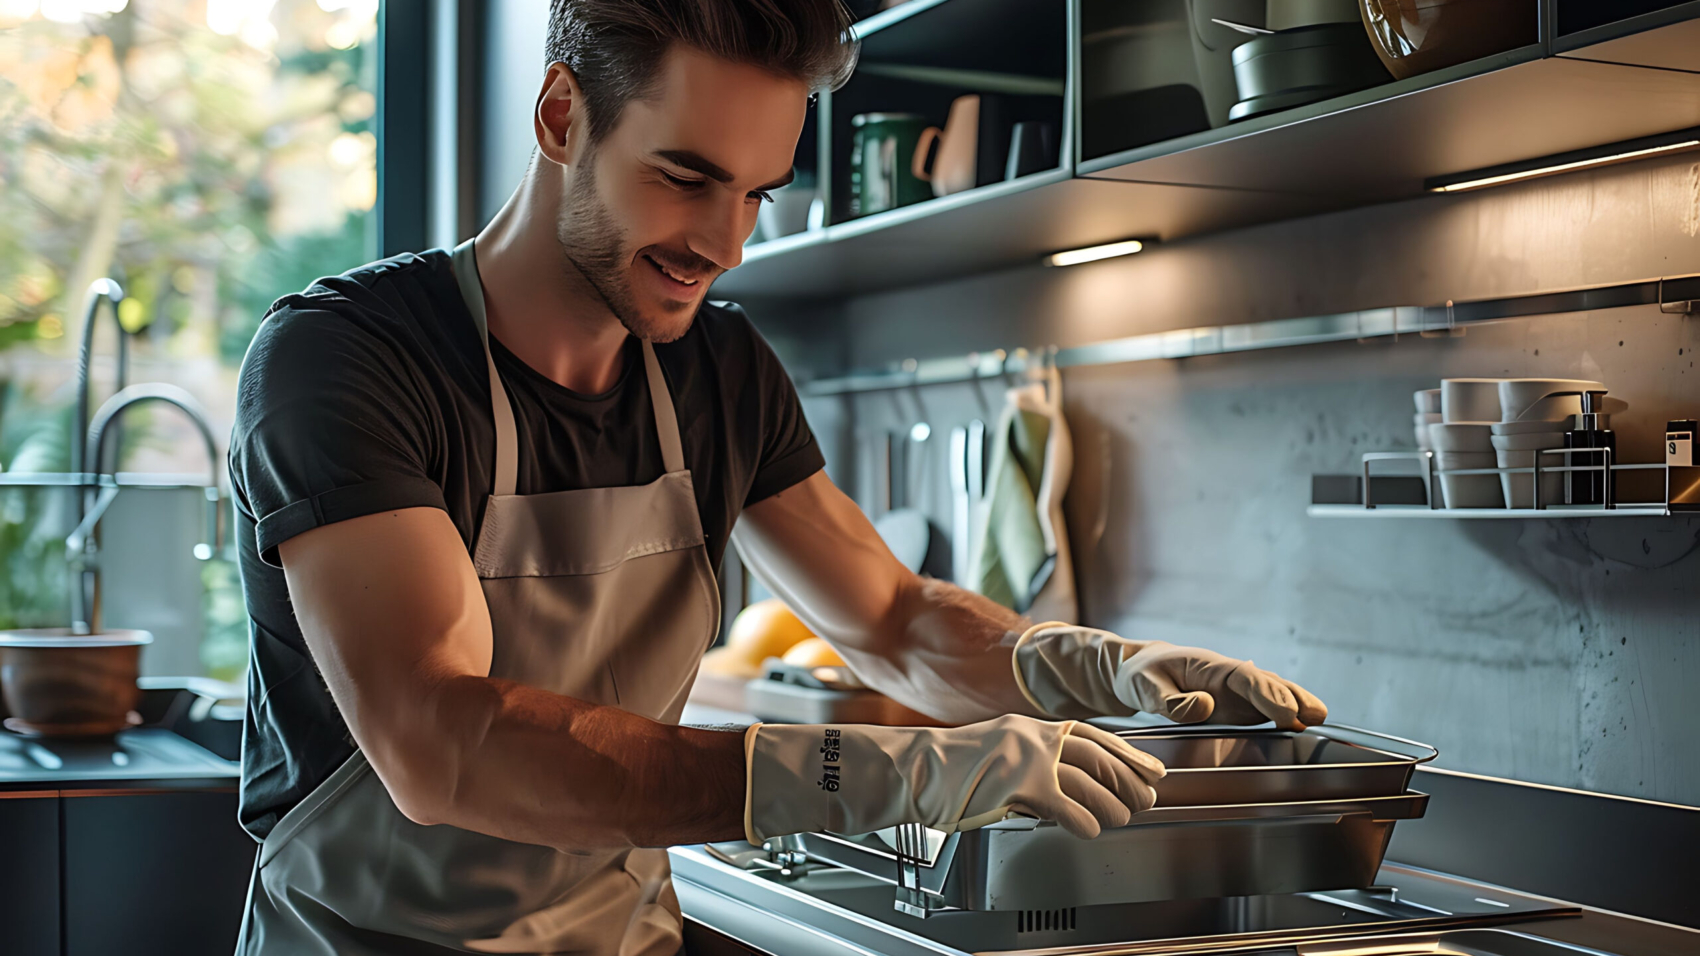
[0,686,258,956]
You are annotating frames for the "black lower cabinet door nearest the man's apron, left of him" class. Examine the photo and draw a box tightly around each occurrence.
[62,791,258,956]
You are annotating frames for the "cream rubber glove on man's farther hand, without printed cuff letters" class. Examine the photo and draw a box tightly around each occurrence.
[1013,623,1328,730]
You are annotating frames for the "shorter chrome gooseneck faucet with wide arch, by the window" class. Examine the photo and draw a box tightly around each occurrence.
[65,382,224,634]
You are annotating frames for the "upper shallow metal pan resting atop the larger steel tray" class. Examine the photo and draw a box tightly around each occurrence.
[1117,725,1440,806]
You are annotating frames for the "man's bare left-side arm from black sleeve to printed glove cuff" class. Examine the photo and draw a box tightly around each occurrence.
[279,509,745,849]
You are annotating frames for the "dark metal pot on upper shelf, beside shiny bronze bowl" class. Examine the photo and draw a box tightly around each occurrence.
[1227,24,1392,119]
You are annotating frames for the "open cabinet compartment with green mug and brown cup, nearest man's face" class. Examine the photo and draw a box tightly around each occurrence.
[716,0,1073,296]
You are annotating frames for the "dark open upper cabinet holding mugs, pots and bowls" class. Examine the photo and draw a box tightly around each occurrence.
[716,0,1700,298]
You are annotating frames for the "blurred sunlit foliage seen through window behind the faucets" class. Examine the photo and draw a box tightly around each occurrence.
[0,0,379,679]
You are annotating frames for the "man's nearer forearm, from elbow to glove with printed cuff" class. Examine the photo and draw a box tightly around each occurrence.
[394,677,745,849]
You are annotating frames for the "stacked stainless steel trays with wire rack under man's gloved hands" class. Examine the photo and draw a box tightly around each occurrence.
[770,726,1437,917]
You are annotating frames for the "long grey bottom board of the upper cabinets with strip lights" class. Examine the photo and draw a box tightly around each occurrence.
[714,0,1700,298]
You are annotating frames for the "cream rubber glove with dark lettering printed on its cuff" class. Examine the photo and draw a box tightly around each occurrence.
[745,714,1163,844]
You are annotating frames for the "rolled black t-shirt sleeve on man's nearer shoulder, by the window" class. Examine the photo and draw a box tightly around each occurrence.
[230,306,445,566]
